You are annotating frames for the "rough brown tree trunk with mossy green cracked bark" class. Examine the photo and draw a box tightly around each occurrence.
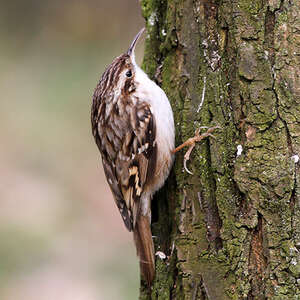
[140,0,300,300]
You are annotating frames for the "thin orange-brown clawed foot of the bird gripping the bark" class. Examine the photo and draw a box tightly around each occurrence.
[173,126,221,175]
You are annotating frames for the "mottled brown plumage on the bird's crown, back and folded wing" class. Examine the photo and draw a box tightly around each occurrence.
[92,54,157,231]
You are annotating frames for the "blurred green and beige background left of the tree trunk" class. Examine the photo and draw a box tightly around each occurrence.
[0,0,144,300]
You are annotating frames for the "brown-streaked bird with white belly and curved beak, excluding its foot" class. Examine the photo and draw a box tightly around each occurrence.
[91,28,175,286]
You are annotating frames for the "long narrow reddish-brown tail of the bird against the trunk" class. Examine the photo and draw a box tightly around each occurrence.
[133,215,155,287]
